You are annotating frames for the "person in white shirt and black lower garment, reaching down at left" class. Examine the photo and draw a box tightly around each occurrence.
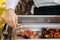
[5,0,60,28]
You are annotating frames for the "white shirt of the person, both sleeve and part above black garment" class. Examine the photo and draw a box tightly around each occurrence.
[6,0,60,9]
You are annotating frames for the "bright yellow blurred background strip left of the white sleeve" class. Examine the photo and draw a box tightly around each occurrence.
[0,0,6,28]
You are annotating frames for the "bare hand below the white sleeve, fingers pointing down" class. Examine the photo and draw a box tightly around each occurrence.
[4,9,18,29]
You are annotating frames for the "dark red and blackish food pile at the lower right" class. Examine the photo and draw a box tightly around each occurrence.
[42,28,60,38]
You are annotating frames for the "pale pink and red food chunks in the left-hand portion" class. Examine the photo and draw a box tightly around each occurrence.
[17,30,39,39]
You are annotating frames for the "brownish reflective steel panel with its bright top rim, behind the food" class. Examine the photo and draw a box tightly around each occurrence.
[18,15,60,23]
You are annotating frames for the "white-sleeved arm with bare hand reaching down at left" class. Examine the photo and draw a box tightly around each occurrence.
[4,0,19,29]
